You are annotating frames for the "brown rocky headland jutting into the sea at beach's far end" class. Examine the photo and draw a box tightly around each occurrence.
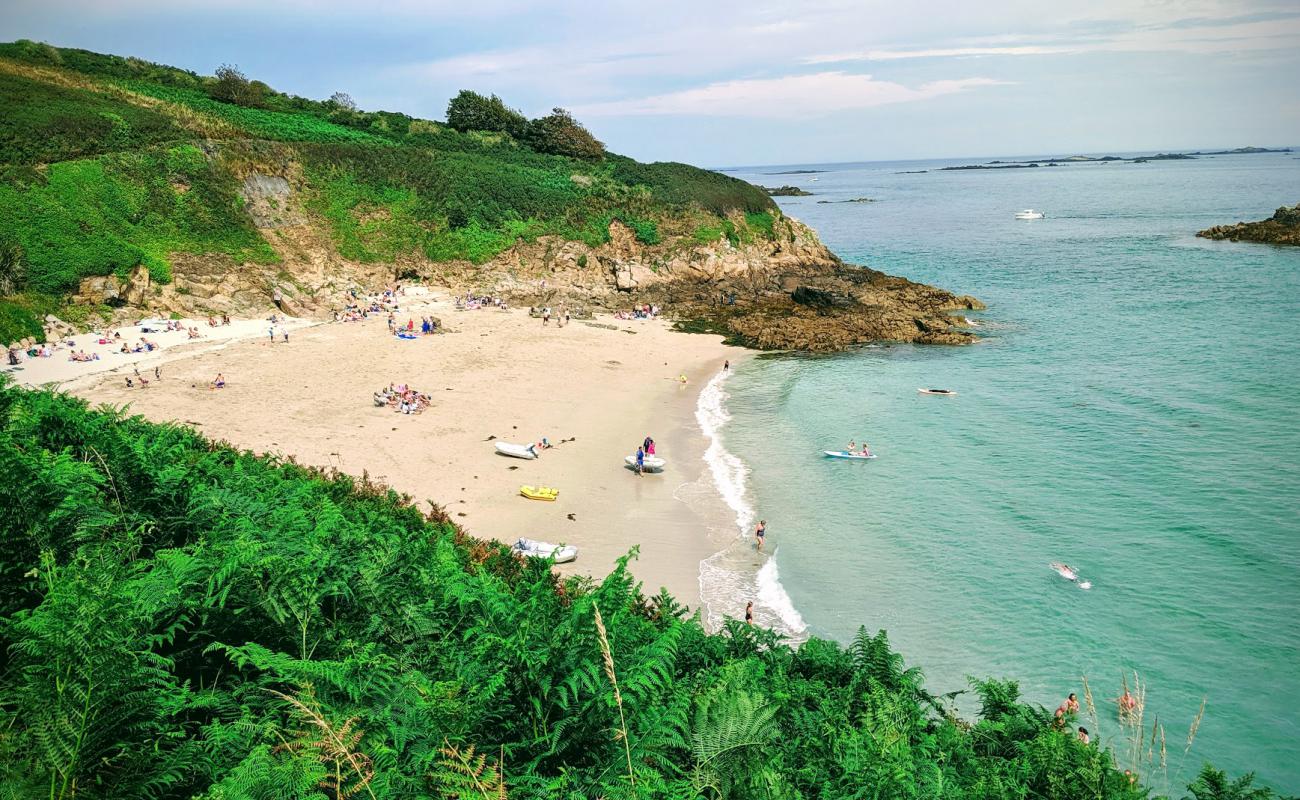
[426,219,983,351]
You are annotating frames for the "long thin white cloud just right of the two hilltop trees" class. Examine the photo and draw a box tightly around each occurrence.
[575,72,1002,118]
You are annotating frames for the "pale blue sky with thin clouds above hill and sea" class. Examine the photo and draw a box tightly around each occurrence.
[0,0,1300,167]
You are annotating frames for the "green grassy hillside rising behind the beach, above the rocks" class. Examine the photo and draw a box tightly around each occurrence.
[0,42,776,340]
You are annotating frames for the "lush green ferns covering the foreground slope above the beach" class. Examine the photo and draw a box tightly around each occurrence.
[0,388,1273,800]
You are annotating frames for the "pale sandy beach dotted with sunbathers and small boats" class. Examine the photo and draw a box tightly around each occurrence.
[43,294,745,607]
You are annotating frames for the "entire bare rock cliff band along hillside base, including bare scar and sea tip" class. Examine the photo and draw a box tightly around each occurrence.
[77,165,983,351]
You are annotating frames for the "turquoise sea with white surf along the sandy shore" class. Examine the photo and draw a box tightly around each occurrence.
[701,151,1300,796]
